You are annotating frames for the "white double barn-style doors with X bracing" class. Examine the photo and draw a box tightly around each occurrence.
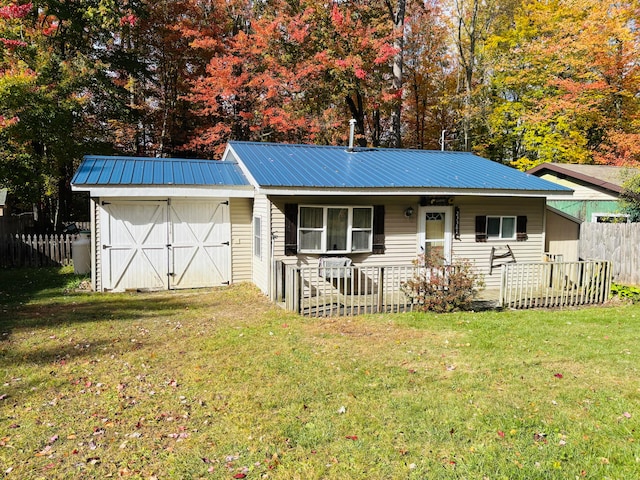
[97,198,231,291]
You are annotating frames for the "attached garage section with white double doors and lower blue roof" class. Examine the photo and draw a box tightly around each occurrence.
[72,156,253,291]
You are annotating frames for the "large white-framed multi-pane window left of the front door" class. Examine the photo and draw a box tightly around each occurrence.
[298,205,373,253]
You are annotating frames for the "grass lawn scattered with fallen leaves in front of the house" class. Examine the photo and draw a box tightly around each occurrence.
[0,270,640,480]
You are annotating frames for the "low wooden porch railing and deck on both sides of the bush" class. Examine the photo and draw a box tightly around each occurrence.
[276,261,611,317]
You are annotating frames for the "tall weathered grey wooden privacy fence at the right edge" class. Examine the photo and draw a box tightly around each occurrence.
[580,223,640,285]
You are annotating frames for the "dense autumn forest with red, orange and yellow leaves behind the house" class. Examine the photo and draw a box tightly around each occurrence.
[0,0,640,228]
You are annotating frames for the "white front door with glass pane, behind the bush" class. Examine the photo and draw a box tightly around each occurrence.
[418,207,453,263]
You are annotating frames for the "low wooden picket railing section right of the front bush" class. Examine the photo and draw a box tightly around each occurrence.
[500,261,611,308]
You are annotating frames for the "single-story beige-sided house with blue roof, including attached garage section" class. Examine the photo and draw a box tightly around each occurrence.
[72,141,572,298]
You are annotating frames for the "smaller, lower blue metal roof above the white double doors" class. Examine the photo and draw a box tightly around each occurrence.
[71,155,249,186]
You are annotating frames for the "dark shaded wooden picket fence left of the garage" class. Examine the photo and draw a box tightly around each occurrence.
[0,234,77,268]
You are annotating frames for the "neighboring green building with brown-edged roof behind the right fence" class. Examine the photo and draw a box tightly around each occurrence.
[527,163,640,222]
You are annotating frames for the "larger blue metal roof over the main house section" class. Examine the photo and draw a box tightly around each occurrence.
[229,141,571,193]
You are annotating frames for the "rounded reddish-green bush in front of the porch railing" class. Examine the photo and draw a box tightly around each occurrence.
[402,253,483,313]
